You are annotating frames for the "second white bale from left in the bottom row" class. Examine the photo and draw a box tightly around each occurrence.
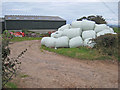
[55,36,69,48]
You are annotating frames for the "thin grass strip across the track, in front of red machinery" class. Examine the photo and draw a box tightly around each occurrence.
[10,37,41,42]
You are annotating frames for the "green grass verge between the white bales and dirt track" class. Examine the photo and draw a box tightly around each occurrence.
[41,46,113,60]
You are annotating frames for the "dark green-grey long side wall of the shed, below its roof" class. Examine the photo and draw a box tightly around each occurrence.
[5,20,66,30]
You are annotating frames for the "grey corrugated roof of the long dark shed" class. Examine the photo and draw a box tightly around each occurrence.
[5,15,65,21]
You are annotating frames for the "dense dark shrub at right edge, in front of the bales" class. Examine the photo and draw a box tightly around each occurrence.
[93,34,118,57]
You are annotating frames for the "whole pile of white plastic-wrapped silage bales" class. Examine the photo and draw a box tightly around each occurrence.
[41,20,116,48]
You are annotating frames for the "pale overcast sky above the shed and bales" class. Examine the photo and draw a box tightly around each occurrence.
[1,0,118,24]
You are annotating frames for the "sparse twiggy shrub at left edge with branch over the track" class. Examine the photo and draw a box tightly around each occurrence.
[2,31,27,87]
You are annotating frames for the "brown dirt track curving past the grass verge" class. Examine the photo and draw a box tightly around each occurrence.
[10,40,118,88]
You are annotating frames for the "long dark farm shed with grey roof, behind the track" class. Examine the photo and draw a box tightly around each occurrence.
[5,15,66,30]
